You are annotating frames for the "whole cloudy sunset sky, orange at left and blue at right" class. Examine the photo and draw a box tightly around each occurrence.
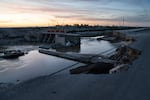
[0,0,150,27]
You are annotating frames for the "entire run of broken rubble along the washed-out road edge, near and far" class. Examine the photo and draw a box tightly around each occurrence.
[70,32,141,74]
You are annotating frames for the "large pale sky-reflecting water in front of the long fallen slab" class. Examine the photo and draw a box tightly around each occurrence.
[0,50,75,82]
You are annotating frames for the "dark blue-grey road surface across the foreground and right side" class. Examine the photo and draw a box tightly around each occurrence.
[0,30,150,100]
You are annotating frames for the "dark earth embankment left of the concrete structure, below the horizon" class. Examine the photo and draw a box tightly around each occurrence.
[0,28,47,45]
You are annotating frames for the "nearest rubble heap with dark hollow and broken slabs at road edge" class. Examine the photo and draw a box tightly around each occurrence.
[70,46,141,74]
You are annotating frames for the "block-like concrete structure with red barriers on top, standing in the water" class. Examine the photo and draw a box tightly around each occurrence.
[42,30,80,46]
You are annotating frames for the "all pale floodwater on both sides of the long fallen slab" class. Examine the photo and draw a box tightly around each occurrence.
[0,38,115,83]
